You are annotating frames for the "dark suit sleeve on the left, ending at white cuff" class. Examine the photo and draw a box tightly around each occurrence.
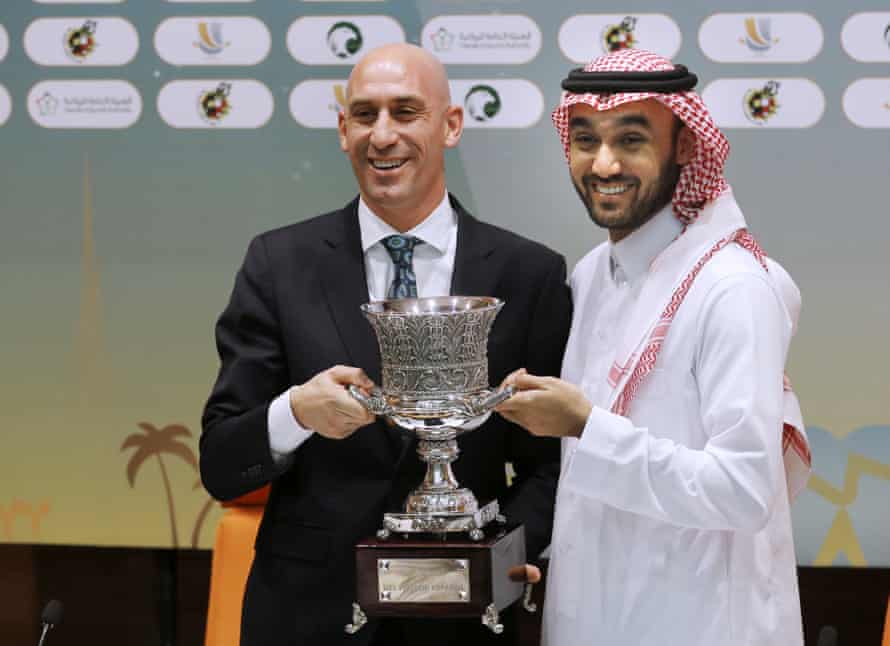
[200,237,290,500]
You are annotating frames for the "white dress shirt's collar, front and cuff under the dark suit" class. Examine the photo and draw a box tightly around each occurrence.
[268,191,457,463]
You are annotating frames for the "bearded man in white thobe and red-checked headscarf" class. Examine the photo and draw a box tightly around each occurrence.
[498,50,809,646]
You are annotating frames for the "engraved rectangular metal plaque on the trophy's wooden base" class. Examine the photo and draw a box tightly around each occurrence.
[377,558,470,603]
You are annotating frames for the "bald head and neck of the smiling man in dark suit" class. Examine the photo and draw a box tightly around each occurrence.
[338,45,463,231]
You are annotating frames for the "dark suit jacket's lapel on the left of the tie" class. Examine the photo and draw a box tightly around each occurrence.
[321,199,380,383]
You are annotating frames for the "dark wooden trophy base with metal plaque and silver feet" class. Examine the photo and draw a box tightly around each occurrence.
[346,523,526,633]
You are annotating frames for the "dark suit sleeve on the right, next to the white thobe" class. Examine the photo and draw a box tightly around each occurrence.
[498,256,572,561]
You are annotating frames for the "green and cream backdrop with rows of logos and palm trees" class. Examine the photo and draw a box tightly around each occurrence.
[0,0,890,566]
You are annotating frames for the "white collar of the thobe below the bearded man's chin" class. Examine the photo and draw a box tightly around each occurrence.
[609,204,683,283]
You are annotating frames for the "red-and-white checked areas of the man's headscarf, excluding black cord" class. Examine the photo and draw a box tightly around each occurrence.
[552,49,812,497]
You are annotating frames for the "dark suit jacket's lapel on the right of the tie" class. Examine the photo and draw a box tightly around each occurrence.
[450,196,498,296]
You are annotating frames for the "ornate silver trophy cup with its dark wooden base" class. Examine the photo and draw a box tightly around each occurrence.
[346,296,525,634]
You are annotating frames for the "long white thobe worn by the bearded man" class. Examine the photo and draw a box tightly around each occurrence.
[544,194,803,646]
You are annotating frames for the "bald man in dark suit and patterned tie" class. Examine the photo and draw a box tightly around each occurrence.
[201,44,571,646]
